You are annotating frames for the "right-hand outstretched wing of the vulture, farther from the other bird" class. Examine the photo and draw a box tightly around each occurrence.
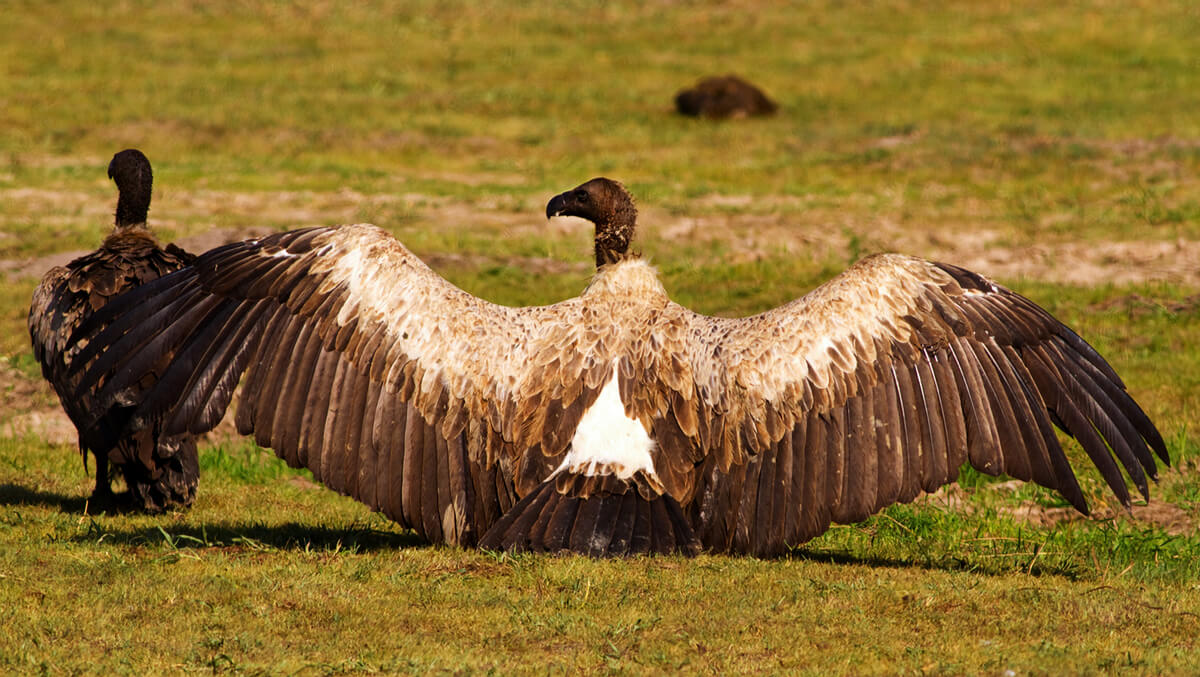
[626,254,1168,553]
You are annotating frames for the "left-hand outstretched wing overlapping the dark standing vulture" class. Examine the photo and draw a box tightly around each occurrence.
[72,226,613,545]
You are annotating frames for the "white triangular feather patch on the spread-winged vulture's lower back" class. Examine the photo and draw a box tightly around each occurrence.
[554,361,654,479]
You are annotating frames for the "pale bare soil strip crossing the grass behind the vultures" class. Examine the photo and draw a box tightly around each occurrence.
[0,188,1200,284]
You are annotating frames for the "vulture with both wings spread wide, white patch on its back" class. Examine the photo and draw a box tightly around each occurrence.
[68,178,1169,556]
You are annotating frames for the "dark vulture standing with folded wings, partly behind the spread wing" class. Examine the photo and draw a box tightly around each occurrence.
[29,149,199,513]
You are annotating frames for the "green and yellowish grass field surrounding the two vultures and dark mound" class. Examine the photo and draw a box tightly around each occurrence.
[0,0,1200,675]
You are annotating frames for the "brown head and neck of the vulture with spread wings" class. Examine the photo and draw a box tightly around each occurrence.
[546,176,637,268]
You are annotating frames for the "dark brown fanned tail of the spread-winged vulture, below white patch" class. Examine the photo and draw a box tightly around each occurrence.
[480,473,700,557]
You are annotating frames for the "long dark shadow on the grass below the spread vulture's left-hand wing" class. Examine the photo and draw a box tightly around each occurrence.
[73,522,428,552]
